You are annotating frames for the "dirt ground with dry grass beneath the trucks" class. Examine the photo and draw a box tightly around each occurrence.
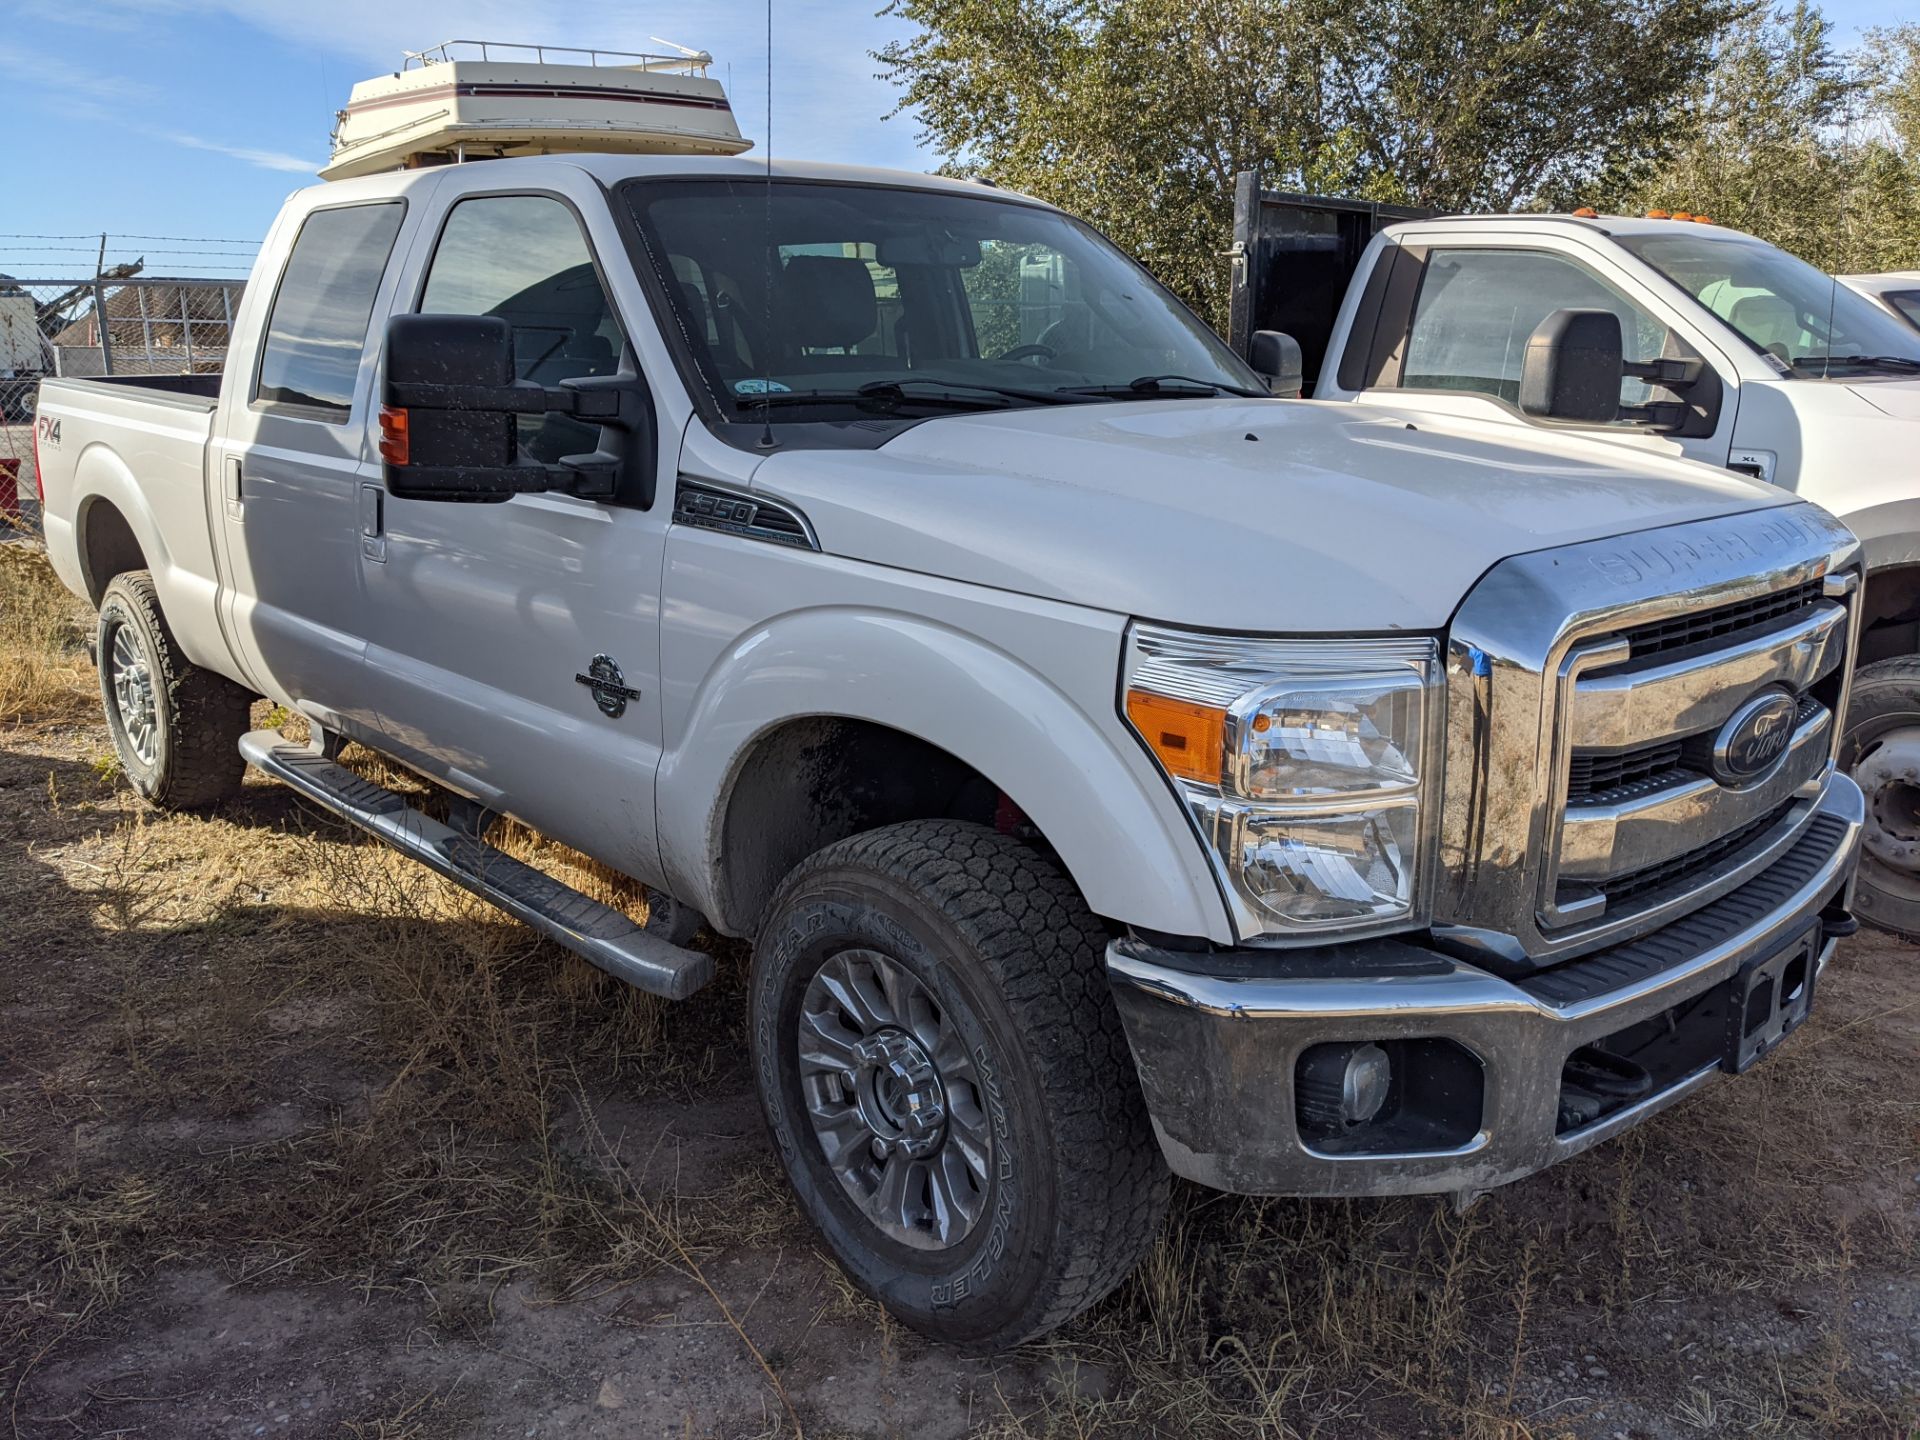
[0,541,1920,1440]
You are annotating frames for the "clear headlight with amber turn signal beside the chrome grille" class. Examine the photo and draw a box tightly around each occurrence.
[1125,626,1442,935]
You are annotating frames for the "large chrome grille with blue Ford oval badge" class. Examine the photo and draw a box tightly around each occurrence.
[1434,503,1859,973]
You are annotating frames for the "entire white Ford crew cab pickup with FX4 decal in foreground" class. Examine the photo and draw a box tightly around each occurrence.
[36,156,1862,1350]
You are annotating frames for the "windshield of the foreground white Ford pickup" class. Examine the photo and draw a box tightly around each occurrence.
[626,180,1267,422]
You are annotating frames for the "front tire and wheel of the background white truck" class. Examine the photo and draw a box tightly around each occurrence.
[1839,655,1920,939]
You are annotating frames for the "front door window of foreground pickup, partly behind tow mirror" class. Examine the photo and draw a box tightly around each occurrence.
[420,196,626,463]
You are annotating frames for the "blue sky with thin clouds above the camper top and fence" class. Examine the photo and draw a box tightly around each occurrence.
[0,0,1914,278]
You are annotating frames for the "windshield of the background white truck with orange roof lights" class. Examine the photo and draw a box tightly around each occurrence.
[1619,230,1920,378]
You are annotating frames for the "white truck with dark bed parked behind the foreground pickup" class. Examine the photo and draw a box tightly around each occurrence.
[1233,175,1920,933]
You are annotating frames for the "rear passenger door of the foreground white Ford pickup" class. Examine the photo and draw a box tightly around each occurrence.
[207,198,405,733]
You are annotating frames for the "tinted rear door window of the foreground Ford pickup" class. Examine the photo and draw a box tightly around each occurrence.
[253,202,403,420]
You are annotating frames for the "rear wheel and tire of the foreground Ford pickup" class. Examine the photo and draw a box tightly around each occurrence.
[96,570,253,810]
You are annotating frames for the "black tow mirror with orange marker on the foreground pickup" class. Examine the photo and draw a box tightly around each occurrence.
[380,315,653,505]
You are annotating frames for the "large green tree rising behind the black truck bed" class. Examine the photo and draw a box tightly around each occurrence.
[876,0,1740,323]
